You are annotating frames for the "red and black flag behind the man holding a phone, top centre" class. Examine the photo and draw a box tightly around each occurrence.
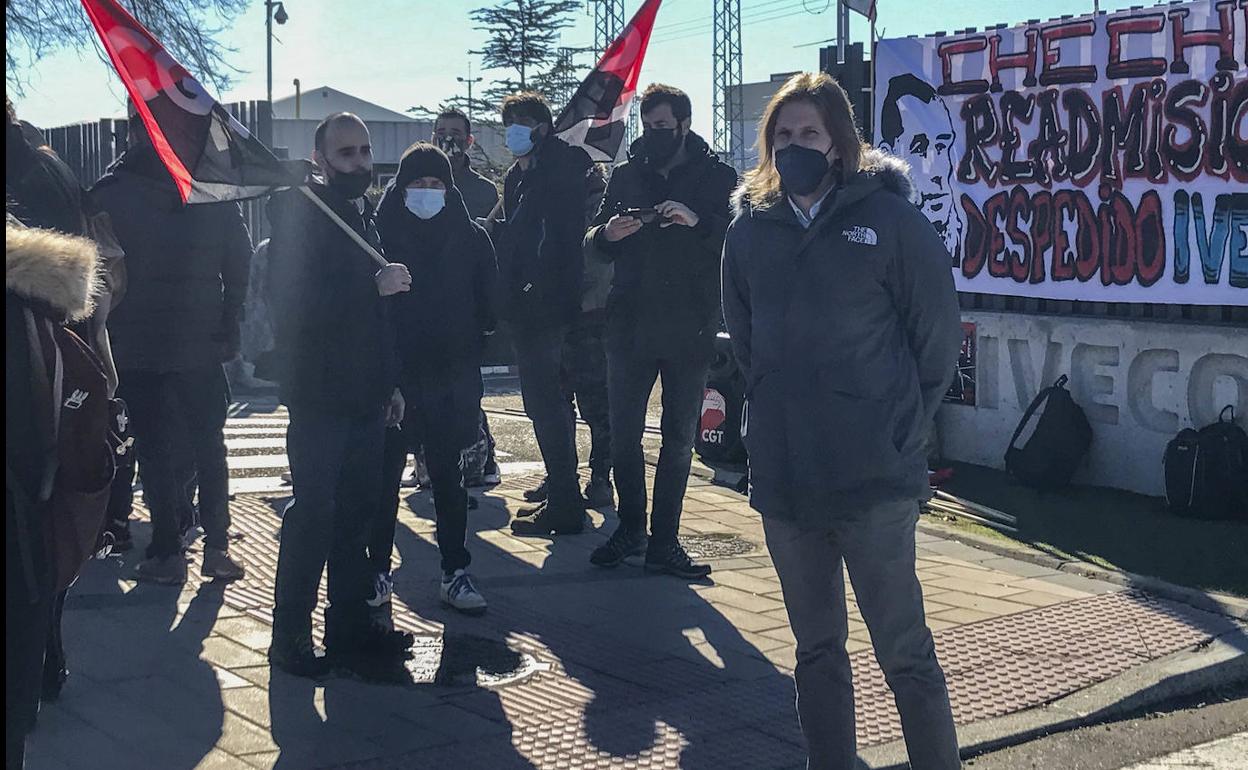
[554,0,663,163]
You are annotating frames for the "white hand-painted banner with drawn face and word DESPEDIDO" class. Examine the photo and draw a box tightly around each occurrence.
[875,0,1248,306]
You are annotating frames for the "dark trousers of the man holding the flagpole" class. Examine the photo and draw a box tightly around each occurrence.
[273,404,386,646]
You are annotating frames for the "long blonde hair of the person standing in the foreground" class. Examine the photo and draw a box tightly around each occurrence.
[741,72,866,206]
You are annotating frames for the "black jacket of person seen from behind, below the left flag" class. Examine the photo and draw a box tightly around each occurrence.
[91,147,251,372]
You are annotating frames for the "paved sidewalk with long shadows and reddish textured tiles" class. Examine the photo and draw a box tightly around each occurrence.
[29,469,1248,770]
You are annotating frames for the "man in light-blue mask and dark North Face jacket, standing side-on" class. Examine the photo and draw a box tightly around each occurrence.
[490,94,605,537]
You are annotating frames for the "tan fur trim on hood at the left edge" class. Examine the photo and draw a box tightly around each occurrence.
[4,218,101,321]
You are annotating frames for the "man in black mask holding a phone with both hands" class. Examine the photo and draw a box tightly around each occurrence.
[587,85,736,579]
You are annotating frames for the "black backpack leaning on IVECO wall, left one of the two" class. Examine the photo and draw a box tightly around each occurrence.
[1006,374,1092,489]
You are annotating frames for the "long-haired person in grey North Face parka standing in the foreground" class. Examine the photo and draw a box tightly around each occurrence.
[723,74,961,770]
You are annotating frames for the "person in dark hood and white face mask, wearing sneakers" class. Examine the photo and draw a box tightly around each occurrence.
[368,142,497,614]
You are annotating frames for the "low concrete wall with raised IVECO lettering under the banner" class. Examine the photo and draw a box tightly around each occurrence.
[937,312,1248,494]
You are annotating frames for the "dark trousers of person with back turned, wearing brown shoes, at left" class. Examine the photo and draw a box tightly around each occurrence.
[120,364,230,558]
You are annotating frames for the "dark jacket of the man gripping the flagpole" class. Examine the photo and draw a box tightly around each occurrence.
[268,183,397,417]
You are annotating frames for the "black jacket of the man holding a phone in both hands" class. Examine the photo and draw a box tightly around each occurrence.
[585,134,736,357]
